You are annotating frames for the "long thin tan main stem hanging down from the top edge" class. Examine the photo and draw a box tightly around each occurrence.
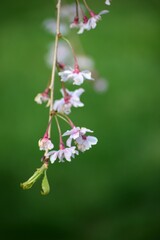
[48,0,61,138]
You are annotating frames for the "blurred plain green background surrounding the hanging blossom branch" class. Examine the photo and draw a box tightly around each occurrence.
[0,0,160,240]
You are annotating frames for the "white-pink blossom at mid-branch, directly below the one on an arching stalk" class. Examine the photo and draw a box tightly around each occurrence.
[53,88,84,114]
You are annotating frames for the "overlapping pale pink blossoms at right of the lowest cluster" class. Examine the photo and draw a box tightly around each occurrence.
[63,127,98,152]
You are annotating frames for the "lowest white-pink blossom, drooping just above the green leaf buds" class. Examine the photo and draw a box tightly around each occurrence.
[47,147,79,163]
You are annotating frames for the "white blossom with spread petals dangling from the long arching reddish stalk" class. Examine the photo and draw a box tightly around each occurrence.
[58,68,93,85]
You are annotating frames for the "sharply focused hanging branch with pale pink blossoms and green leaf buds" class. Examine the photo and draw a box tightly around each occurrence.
[21,0,110,195]
